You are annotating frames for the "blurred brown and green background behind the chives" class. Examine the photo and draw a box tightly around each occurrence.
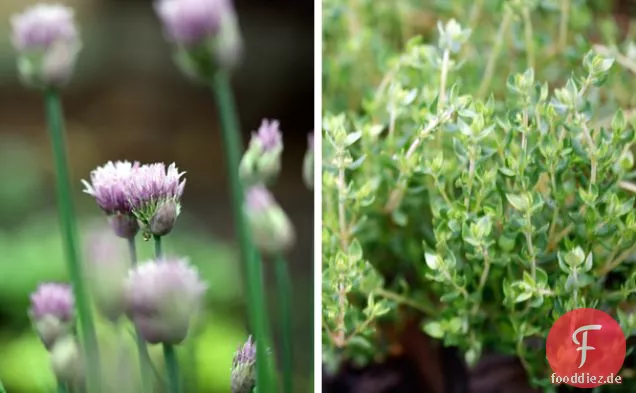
[0,0,314,393]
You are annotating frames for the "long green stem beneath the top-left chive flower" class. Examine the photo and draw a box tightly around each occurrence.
[44,89,101,393]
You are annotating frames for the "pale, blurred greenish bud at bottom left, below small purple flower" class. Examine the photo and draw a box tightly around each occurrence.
[51,336,84,385]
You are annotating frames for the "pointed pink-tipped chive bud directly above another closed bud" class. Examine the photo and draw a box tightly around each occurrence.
[239,119,283,184]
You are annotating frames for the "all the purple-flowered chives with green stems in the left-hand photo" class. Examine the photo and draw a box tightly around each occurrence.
[9,0,313,393]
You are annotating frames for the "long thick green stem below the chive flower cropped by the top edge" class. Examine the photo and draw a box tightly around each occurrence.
[212,71,273,393]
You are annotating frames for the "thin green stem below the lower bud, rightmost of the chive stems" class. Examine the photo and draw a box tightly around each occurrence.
[275,255,294,393]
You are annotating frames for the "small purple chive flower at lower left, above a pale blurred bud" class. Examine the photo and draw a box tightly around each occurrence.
[29,283,75,349]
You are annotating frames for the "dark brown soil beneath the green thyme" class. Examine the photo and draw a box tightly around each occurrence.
[322,318,636,393]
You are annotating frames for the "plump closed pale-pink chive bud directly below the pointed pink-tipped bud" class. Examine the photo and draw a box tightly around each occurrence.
[245,186,295,256]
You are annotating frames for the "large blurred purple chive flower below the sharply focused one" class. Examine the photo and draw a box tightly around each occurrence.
[126,259,207,344]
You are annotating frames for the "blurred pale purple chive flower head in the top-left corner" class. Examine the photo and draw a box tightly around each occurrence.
[11,4,81,88]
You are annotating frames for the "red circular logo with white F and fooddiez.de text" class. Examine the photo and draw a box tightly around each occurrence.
[546,308,626,388]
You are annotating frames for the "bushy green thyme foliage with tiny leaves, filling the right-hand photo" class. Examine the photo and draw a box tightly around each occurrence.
[322,0,636,387]
